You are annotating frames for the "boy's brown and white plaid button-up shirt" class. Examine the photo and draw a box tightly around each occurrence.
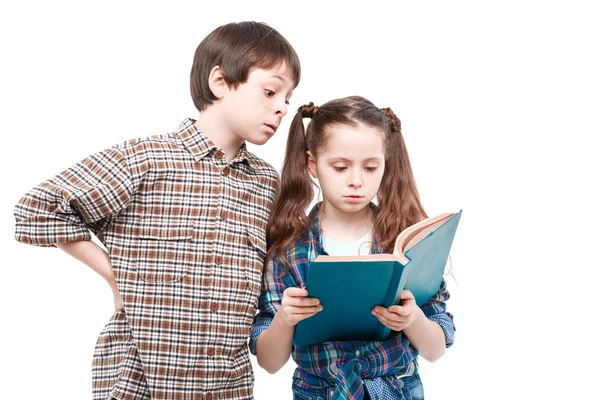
[15,119,278,400]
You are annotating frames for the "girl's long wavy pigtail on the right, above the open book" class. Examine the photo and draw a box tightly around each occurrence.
[374,108,427,253]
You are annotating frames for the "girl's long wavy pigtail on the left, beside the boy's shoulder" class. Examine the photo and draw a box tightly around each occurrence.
[264,103,318,272]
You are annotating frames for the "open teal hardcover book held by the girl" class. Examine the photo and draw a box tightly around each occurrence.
[293,210,462,346]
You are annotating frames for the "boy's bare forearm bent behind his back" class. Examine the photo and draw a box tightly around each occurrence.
[56,240,123,312]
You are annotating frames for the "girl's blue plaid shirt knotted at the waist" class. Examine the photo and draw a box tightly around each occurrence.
[250,204,455,399]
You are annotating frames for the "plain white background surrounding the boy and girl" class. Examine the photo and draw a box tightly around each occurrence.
[0,0,600,400]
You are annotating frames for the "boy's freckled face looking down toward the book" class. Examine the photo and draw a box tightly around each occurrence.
[222,63,294,145]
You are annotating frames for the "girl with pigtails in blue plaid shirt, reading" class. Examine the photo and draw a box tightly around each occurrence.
[250,96,454,399]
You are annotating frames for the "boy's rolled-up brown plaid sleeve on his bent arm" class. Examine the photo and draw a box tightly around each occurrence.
[14,148,133,247]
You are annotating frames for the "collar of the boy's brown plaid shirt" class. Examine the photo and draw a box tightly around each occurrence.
[176,118,258,169]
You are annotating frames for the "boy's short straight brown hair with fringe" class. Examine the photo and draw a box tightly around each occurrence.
[190,21,300,112]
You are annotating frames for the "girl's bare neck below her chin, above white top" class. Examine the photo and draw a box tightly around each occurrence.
[319,202,373,241]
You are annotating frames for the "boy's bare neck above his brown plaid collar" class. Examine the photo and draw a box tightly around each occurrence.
[194,106,244,163]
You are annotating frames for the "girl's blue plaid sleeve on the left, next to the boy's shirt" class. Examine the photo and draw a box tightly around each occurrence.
[248,255,298,355]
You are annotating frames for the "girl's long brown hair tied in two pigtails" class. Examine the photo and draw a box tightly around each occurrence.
[265,96,427,271]
